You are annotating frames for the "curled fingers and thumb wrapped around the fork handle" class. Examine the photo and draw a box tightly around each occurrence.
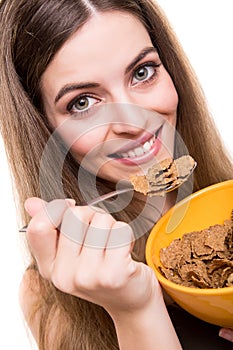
[25,198,135,301]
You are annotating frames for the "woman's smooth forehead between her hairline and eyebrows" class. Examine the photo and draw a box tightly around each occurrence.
[42,11,151,89]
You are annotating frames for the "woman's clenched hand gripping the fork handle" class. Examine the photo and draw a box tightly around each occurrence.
[25,198,163,315]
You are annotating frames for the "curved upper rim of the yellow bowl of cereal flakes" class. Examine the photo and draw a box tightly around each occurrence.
[146,179,233,295]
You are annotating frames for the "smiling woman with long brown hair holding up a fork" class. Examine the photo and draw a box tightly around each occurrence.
[0,0,233,349]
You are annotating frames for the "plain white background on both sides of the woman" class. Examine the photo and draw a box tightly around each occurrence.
[0,0,233,350]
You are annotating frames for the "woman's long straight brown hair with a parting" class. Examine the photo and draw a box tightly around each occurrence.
[0,0,233,350]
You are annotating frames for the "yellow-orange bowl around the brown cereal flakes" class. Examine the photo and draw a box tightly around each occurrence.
[146,180,233,327]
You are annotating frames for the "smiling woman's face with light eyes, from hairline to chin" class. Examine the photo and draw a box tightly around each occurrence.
[41,12,178,182]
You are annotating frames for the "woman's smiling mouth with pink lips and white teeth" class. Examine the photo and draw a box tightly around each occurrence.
[108,125,163,165]
